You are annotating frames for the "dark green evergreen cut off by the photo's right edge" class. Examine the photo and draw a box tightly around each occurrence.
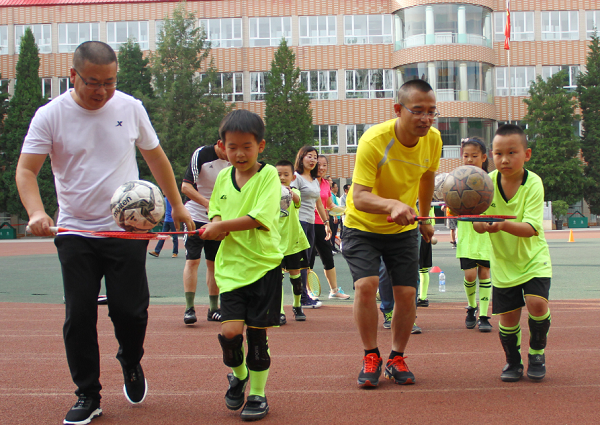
[577,32,600,214]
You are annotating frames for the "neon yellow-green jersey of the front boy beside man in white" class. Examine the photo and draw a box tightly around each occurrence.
[208,164,283,293]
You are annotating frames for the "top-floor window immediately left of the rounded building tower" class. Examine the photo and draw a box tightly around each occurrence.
[344,15,392,44]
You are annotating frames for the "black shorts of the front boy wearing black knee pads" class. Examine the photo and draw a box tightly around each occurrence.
[221,266,283,328]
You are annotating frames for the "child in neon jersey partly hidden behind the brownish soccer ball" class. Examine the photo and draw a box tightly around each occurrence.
[456,137,492,332]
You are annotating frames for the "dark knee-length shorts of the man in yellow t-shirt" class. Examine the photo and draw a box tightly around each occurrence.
[342,227,419,288]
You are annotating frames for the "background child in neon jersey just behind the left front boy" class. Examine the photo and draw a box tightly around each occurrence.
[275,160,310,325]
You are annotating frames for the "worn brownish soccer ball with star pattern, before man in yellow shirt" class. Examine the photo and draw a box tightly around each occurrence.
[441,165,494,215]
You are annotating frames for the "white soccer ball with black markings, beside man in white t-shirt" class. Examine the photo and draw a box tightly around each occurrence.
[110,180,165,232]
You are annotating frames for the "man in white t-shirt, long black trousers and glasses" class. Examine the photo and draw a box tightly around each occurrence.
[16,41,194,424]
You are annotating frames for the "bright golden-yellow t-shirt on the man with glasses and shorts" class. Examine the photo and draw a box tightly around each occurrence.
[344,119,442,234]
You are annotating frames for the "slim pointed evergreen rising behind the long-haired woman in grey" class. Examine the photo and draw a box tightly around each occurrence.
[263,39,314,164]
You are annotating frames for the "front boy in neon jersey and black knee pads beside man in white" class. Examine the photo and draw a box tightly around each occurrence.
[202,109,283,420]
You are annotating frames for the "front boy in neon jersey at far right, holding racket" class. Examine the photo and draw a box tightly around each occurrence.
[473,124,552,382]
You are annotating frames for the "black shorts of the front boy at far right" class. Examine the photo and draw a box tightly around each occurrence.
[492,277,550,314]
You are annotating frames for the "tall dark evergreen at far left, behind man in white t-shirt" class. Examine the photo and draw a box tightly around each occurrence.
[0,28,53,217]
